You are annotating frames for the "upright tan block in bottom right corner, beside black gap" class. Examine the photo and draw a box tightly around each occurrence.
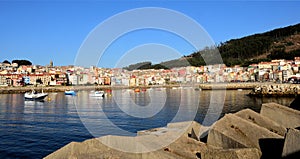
[282,128,300,158]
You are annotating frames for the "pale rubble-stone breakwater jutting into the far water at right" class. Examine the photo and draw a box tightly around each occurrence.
[249,84,300,96]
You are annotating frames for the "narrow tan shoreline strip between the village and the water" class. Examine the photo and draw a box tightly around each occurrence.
[0,82,300,96]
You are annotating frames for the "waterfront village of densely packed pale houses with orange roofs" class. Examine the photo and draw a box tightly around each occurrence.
[0,57,300,86]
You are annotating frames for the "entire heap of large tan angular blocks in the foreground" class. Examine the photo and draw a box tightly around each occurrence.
[46,103,300,159]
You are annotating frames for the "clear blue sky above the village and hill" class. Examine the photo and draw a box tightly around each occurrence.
[0,0,300,67]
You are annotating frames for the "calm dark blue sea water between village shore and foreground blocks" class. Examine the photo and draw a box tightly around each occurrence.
[0,89,293,158]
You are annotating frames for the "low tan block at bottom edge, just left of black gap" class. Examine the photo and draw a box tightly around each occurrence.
[201,148,261,159]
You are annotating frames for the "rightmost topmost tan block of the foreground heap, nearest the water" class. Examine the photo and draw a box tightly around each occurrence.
[260,103,300,128]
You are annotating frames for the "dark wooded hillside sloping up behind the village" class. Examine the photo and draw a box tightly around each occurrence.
[127,23,300,69]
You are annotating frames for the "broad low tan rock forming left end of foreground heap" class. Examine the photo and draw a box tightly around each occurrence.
[46,122,207,159]
